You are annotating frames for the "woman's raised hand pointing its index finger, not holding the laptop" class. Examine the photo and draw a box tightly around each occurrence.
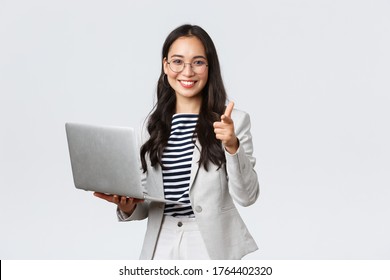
[214,101,238,154]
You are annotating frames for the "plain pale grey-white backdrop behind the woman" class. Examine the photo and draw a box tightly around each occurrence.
[0,0,390,260]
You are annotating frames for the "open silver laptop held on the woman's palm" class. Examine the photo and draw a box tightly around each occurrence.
[65,123,184,204]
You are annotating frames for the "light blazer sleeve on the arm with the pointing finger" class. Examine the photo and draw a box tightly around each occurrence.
[225,110,260,206]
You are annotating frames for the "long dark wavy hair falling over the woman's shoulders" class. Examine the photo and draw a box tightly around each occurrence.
[141,24,227,172]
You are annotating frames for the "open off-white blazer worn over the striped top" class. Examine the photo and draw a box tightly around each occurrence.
[117,109,260,259]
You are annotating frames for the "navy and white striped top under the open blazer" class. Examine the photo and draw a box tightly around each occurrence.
[162,114,198,217]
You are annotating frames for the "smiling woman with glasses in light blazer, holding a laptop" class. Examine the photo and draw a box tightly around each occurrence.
[95,25,259,259]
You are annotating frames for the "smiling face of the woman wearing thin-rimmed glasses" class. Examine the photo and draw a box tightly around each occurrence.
[163,36,208,101]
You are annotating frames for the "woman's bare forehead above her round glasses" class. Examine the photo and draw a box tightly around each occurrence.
[168,36,206,58]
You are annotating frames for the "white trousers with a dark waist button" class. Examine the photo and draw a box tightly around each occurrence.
[153,216,210,260]
